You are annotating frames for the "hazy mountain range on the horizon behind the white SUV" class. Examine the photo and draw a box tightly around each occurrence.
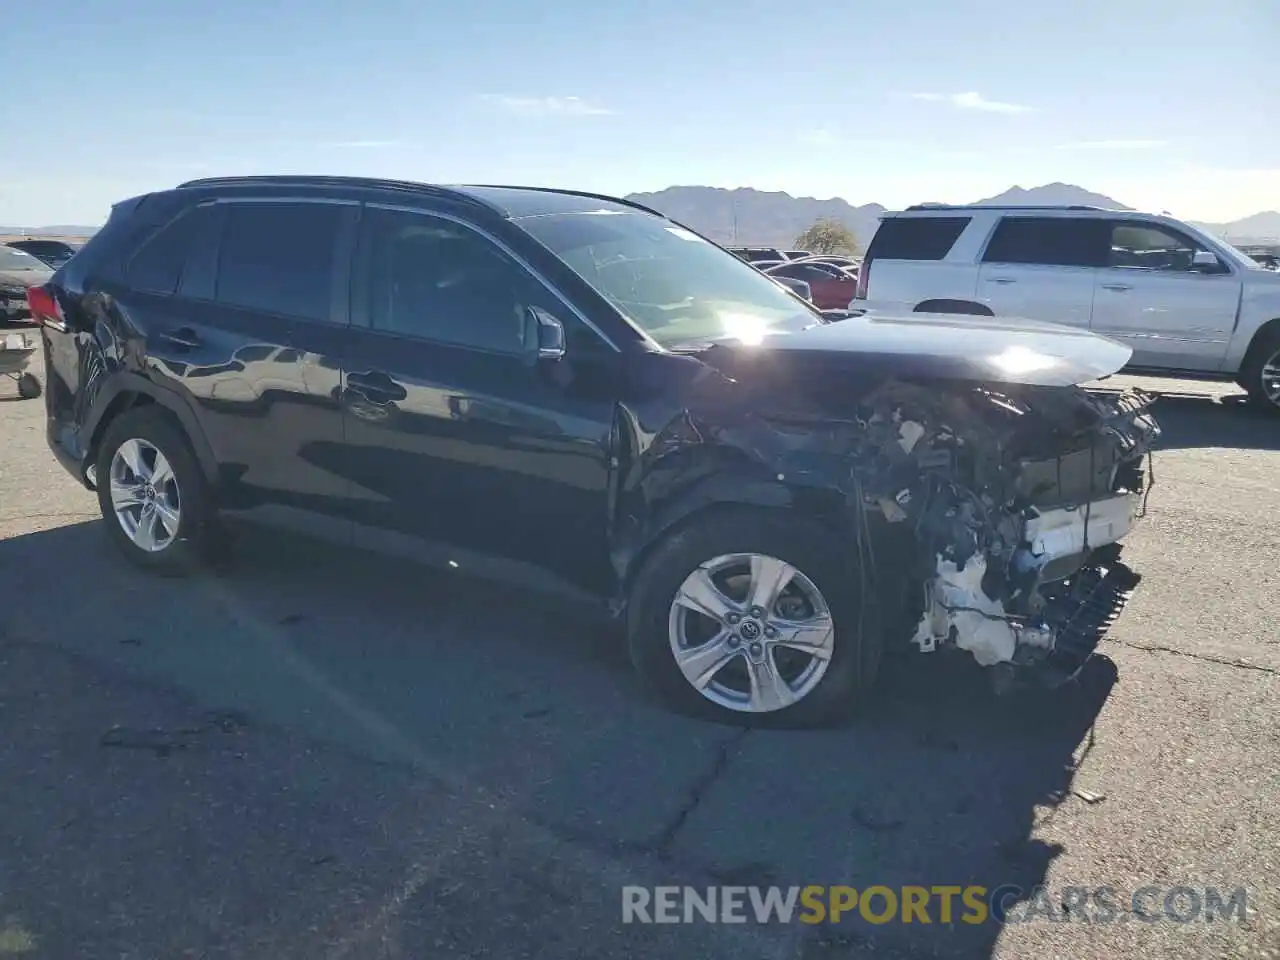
[627,183,1280,248]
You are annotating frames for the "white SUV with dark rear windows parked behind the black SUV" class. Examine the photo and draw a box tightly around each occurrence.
[850,205,1280,412]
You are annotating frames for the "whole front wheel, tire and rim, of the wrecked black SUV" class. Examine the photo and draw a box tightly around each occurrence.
[628,508,879,726]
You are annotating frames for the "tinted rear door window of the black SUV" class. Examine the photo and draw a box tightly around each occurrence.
[215,202,342,320]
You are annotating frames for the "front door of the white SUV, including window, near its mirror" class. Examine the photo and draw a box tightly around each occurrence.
[1093,220,1242,370]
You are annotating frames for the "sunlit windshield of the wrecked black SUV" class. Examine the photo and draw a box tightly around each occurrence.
[520,210,822,348]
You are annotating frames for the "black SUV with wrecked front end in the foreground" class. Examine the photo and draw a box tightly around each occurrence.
[37,177,1156,723]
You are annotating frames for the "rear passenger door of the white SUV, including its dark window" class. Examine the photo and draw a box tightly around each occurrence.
[977,215,1107,329]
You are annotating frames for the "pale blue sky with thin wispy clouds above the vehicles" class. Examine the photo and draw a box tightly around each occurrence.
[0,0,1280,225]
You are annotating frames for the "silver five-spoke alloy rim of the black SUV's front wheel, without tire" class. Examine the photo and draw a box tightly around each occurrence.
[668,553,835,713]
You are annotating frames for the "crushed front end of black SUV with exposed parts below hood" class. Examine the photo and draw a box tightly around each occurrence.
[855,381,1160,685]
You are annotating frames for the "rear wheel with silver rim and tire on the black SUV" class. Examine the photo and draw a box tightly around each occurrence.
[96,407,211,573]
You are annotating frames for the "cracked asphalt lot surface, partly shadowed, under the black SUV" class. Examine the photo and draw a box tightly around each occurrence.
[0,350,1280,959]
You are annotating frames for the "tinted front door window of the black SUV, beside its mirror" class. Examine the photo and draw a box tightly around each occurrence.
[369,211,554,353]
